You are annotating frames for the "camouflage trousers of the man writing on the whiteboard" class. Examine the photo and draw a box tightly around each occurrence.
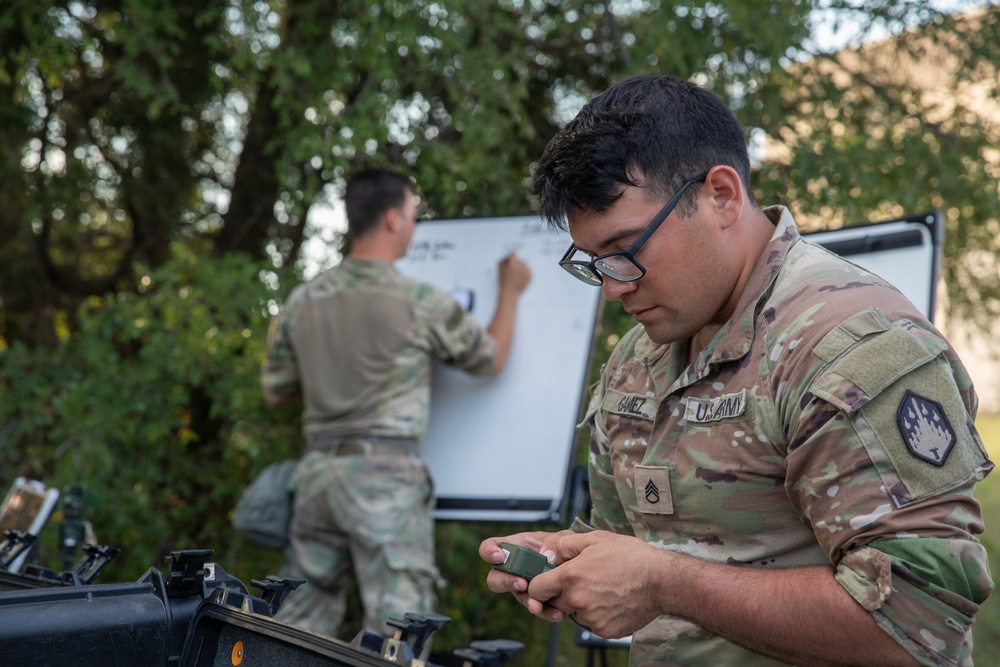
[275,452,440,637]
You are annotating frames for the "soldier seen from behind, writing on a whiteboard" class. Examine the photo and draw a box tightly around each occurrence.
[261,170,531,636]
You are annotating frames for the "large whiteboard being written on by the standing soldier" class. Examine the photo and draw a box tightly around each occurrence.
[397,216,601,522]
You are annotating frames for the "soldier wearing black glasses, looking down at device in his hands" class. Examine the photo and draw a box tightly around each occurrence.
[480,76,993,666]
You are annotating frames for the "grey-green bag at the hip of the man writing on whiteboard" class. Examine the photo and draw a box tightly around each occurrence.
[233,459,298,549]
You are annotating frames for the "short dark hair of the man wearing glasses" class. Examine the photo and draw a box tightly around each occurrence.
[532,74,757,228]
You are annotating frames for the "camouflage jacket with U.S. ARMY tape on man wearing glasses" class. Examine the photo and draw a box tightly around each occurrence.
[577,207,993,667]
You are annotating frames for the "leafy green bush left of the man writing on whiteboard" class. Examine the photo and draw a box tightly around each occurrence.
[0,246,299,580]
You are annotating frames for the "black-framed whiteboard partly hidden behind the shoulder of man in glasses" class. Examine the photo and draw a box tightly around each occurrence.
[802,211,944,322]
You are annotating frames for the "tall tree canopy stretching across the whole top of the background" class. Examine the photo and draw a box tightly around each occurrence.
[0,0,998,345]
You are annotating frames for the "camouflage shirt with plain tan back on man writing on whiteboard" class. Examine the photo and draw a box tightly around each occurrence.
[261,257,496,440]
